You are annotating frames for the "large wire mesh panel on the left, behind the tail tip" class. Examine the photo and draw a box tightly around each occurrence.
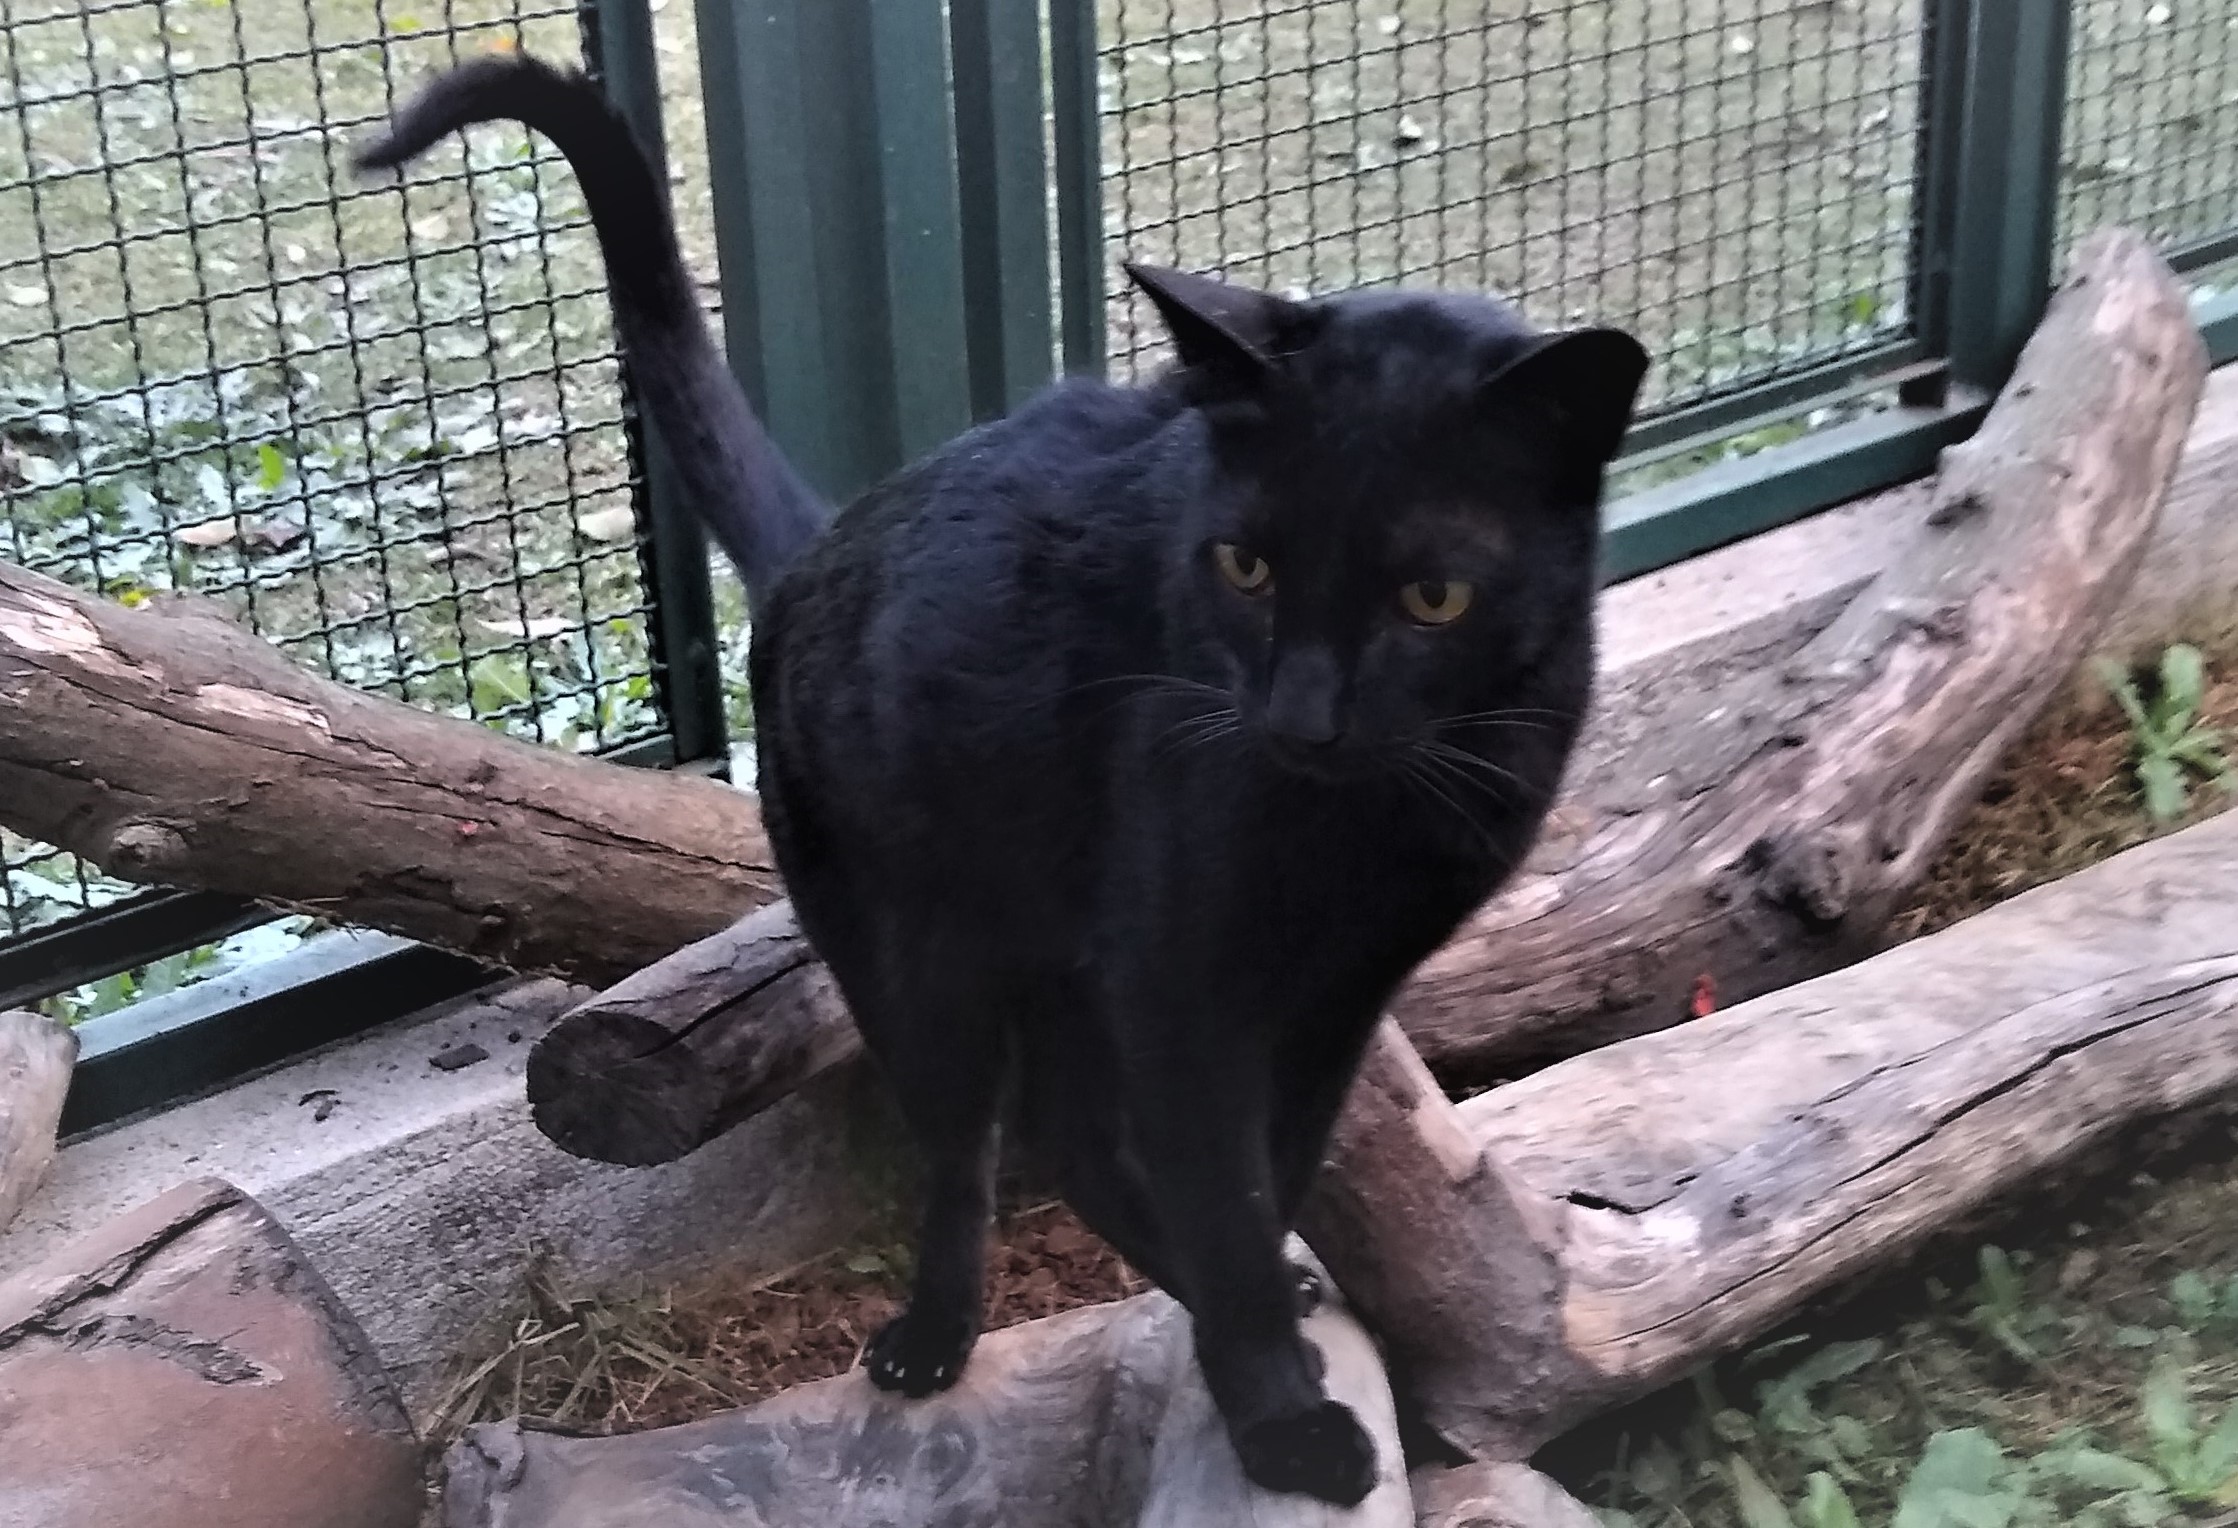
[0,0,660,935]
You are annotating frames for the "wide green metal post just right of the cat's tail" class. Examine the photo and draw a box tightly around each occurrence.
[698,0,971,499]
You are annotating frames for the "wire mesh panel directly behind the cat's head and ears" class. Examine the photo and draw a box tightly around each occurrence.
[1099,0,1922,407]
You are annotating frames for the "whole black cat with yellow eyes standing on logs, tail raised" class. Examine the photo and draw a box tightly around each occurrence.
[363,58,1645,1503]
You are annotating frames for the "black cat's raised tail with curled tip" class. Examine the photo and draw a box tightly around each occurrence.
[356,54,830,609]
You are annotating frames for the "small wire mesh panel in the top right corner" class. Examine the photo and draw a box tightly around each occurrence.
[2059,0,2238,271]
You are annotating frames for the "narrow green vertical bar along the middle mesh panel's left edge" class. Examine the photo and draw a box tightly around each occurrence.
[1050,0,1106,376]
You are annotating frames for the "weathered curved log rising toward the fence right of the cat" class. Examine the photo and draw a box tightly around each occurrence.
[1394,230,2207,1072]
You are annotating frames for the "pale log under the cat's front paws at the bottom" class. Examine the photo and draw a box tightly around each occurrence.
[443,1261,1414,1528]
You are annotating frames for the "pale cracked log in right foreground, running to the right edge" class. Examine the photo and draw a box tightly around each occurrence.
[1305,812,2238,1459]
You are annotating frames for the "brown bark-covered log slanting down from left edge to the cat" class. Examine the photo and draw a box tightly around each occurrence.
[0,564,777,984]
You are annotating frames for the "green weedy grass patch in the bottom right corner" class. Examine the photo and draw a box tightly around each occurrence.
[1542,1128,2238,1528]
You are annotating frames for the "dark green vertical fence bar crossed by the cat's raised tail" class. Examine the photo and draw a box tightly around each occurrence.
[582,0,730,761]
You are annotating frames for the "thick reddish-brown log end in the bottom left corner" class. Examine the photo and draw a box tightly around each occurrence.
[0,1179,421,1528]
